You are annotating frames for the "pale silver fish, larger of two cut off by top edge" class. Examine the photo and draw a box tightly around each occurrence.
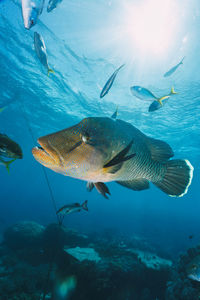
[21,0,44,29]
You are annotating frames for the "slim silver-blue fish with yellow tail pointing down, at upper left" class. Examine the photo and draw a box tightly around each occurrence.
[34,32,54,76]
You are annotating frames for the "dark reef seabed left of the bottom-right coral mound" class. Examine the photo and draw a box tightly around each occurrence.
[0,222,172,300]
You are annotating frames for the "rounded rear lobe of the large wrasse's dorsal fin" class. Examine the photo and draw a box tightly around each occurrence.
[146,138,174,162]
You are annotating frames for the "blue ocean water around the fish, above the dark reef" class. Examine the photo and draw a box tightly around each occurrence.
[0,0,200,298]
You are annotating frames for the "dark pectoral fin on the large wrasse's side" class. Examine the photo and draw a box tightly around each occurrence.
[103,141,136,173]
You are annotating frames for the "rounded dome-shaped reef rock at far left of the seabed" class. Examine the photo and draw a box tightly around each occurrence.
[4,221,44,249]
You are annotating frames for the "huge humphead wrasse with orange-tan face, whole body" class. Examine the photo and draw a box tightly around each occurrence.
[32,117,193,197]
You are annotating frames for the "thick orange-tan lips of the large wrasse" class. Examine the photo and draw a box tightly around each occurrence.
[32,137,60,168]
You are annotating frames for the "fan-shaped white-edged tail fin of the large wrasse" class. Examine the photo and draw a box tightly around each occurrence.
[153,159,194,197]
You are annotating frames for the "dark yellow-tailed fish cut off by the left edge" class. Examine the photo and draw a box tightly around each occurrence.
[0,133,23,172]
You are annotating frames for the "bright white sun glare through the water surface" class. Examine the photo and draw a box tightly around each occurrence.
[119,0,179,55]
